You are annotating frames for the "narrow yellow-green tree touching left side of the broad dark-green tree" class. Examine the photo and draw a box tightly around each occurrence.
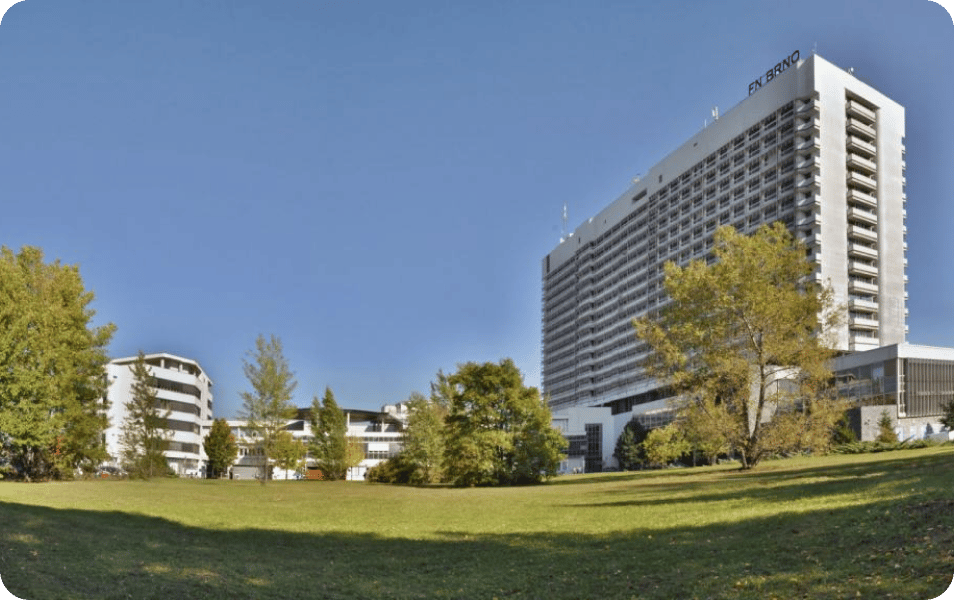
[402,390,448,484]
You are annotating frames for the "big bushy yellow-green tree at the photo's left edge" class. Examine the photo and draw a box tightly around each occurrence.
[0,246,116,481]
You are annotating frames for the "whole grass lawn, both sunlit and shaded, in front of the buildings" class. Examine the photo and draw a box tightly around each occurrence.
[0,445,954,600]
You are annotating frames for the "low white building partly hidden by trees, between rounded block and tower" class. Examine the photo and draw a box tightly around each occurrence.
[228,404,407,481]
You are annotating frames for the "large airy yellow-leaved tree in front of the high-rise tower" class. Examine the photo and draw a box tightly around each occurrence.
[634,223,841,469]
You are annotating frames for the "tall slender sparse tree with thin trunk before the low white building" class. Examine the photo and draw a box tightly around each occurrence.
[240,335,298,484]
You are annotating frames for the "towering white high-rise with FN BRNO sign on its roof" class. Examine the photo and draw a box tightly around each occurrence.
[543,52,907,414]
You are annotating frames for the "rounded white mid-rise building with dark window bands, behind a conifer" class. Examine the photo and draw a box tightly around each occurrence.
[105,353,212,477]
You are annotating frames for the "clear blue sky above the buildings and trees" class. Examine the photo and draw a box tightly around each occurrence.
[0,0,954,417]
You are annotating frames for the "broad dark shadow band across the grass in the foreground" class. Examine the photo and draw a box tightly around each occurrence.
[0,498,954,600]
